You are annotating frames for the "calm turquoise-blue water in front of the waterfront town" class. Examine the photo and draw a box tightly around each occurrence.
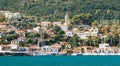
[0,56,120,66]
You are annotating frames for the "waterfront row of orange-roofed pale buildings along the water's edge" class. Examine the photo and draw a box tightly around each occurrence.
[0,43,120,56]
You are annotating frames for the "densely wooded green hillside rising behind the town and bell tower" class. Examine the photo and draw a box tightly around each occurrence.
[0,0,120,21]
